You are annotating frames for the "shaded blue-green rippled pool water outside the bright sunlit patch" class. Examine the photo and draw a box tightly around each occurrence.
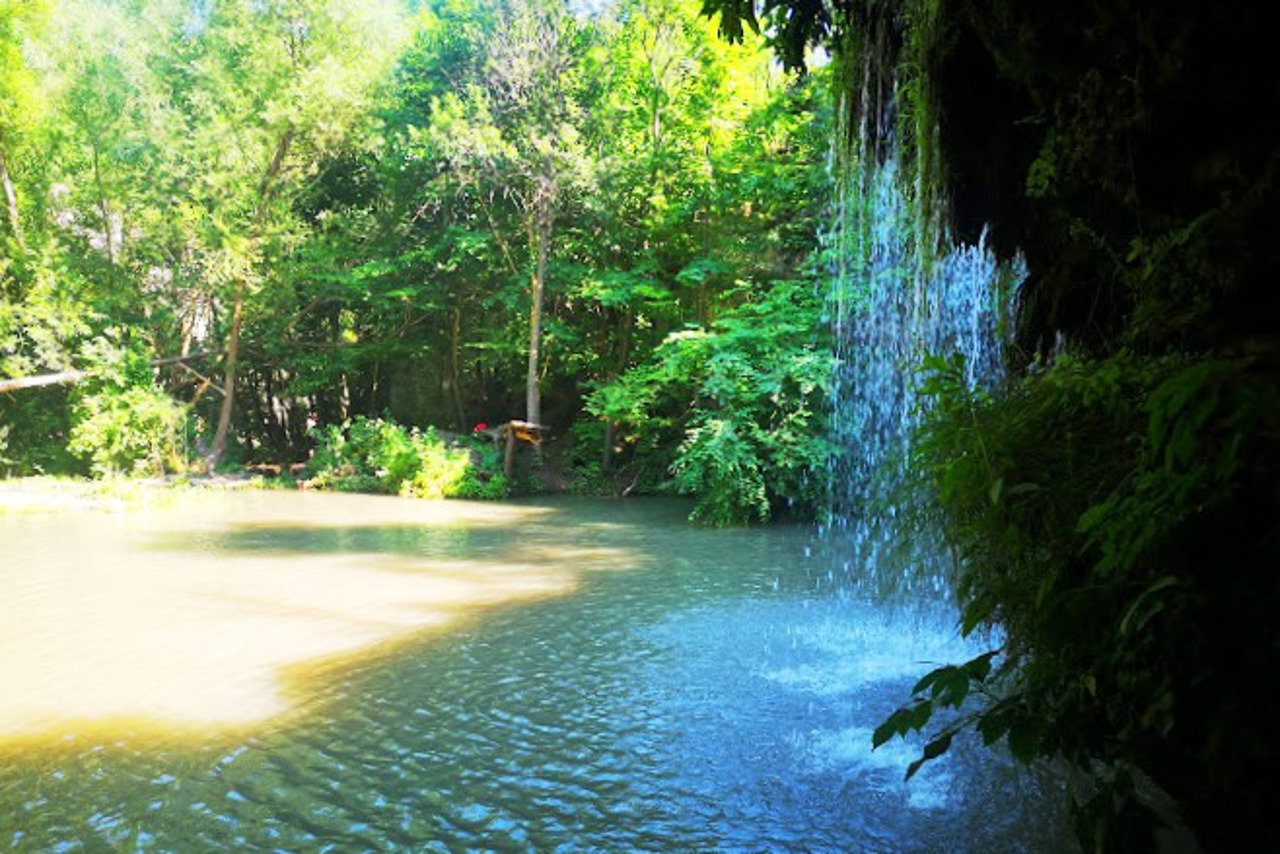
[0,494,1070,851]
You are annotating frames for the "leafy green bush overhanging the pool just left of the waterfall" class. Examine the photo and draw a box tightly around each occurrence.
[588,282,832,525]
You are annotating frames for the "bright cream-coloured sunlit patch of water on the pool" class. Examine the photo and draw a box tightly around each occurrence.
[0,492,628,740]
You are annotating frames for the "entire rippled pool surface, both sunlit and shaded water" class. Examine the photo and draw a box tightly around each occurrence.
[0,493,1064,851]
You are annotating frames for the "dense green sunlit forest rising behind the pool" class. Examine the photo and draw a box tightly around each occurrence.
[0,0,829,521]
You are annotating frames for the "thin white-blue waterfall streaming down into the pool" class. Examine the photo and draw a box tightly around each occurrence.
[823,96,1023,594]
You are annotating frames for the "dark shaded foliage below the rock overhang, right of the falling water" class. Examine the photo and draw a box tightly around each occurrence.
[876,353,1280,850]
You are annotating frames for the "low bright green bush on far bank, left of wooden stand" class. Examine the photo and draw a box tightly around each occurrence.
[308,416,507,499]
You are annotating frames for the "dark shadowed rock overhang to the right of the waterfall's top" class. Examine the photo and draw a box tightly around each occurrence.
[927,0,1280,351]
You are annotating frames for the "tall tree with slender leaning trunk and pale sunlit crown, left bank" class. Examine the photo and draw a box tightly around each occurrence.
[151,0,398,463]
